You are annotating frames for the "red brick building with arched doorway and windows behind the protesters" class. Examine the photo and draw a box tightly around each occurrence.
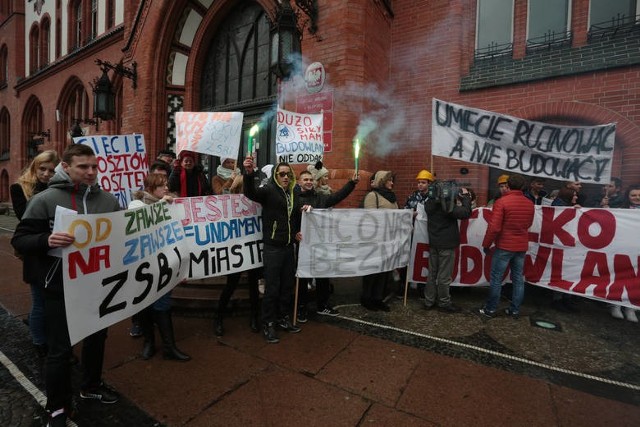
[0,0,640,207]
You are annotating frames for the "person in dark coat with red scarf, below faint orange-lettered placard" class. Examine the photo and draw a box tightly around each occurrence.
[169,151,211,197]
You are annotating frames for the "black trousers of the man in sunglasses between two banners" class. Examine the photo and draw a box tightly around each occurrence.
[262,244,296,324]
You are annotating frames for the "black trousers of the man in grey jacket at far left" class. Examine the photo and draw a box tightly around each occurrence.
[44,289,107,411]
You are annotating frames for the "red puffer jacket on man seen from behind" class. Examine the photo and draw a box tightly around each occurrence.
[482,190,535,252]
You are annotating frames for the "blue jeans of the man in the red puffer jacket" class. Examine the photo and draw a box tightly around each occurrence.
[484,248,525,313]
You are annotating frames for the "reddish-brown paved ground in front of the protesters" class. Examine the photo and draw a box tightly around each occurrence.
[0,212,640,426]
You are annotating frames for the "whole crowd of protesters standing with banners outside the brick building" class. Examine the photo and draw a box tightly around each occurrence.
[11,146,640,425]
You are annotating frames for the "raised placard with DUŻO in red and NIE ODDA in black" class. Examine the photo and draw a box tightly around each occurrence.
[276,108,324,164]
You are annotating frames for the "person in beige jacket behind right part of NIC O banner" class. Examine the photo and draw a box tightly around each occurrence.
[360,171,398,311]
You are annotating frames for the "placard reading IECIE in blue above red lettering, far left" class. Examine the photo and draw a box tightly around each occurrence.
[73,134,149,209]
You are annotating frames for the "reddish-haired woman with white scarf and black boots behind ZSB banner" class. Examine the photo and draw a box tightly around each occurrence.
[129,173,191,362]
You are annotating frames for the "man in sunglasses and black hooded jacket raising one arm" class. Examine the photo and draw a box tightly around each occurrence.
[243,157,300,344]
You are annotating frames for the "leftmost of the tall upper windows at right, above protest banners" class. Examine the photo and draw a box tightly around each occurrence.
[476,0,513,56]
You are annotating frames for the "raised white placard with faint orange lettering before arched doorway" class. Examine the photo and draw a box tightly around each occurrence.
[175,111,244,159]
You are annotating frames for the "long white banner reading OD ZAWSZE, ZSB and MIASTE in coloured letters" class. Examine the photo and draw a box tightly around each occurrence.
[60,194,262,344]
